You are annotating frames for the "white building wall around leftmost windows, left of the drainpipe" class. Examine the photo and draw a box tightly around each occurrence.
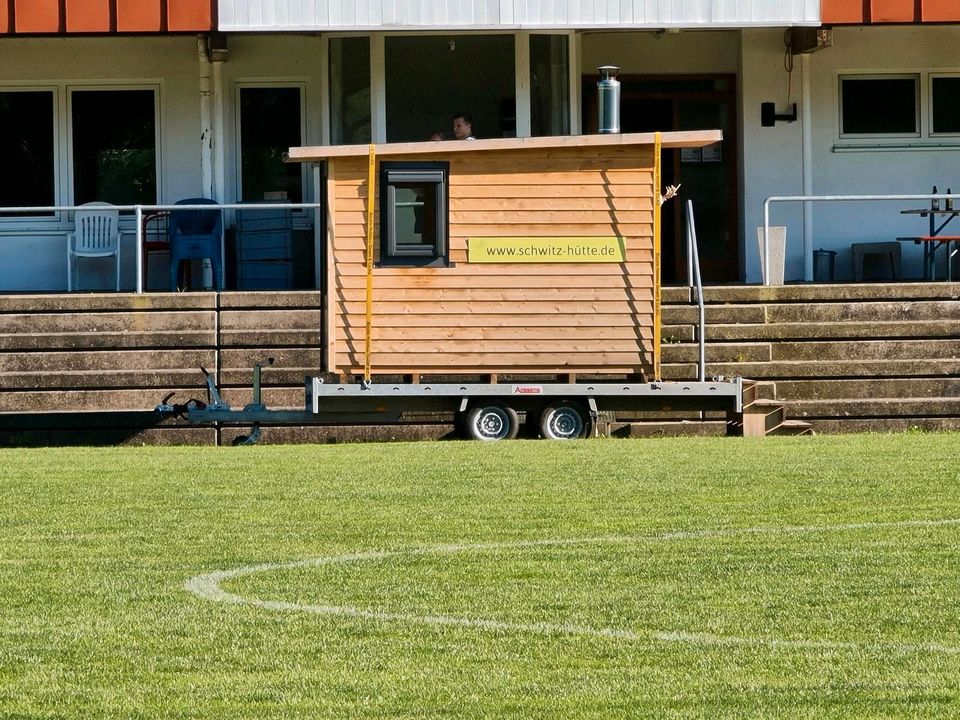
[0,37,201,291]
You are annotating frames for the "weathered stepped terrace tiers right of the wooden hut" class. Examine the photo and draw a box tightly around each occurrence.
[662,283,960,434]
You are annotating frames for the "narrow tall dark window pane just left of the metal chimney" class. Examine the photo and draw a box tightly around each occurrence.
[530,35,570,137]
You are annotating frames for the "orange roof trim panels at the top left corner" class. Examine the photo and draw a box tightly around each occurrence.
[0,0,217,35]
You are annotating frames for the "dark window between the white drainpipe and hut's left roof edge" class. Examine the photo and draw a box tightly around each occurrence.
[238,87,303,203]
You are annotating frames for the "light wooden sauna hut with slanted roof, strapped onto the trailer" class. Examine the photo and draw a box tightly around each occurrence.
[289,131,721,382]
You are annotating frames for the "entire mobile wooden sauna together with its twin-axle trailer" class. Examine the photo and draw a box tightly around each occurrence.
[166,131,742,440]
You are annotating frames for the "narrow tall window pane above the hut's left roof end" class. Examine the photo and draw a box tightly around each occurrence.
[330,37,372,145]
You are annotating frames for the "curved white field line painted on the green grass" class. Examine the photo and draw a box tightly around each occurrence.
[184,518,960,655]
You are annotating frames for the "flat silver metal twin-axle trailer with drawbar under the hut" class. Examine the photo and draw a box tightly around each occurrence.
[157,363,743,445]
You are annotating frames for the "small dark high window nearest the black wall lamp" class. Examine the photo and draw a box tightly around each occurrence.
[840,75,920,137]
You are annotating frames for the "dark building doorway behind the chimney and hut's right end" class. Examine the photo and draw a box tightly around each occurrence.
[583,75,741,284]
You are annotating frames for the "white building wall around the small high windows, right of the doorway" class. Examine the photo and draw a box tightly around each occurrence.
[743,26,960,281]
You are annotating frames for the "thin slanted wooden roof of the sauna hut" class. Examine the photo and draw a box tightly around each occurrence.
[287,130,723,162]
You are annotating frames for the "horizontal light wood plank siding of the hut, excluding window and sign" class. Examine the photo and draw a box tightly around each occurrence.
[331,146,653,375]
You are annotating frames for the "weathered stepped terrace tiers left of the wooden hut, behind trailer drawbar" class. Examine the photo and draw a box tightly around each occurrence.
[0,292,321,444]
